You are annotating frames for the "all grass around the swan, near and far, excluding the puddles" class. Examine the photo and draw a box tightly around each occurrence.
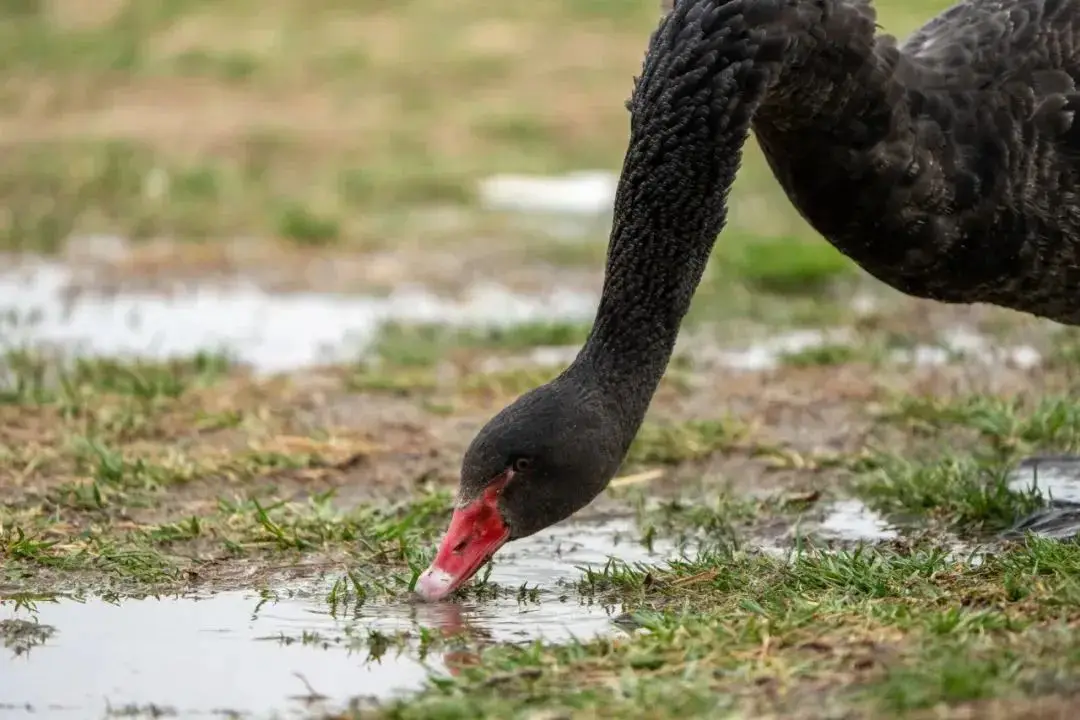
[8,0,1080,720]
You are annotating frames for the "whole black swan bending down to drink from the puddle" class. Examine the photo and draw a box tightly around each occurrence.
[417,0,1080,600]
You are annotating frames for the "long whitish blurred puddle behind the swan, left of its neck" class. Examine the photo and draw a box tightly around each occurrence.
[0,262,596,371]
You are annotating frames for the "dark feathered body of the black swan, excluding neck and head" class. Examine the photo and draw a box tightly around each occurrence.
[753,0,1080,324]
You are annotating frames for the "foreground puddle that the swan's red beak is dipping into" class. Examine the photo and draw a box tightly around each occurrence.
[0,518,675,719]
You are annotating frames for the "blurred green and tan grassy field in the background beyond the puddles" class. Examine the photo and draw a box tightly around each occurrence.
[0,0,945,273]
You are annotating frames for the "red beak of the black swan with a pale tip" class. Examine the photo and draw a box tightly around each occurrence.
[416,476,510,602]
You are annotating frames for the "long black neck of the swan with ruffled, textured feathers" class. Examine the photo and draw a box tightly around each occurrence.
[570,1,781,427]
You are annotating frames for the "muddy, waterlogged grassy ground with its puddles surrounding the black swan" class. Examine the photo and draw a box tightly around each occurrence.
[0,0,1080,720]
